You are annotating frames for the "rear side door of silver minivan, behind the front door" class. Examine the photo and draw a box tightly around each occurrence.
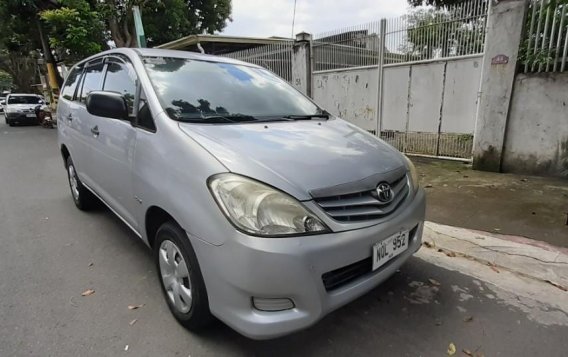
[72,57,105,188]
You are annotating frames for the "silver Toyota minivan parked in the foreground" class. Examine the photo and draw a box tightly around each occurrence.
[57,49,425,339]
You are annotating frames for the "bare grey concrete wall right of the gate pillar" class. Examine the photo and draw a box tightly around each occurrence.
[502,73,568,178]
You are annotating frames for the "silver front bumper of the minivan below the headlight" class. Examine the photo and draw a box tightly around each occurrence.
[190,189,425,339]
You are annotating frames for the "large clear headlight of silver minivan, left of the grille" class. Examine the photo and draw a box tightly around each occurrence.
[209,173,329,237]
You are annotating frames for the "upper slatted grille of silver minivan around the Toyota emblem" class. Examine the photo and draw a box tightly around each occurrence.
[314,174,409,222]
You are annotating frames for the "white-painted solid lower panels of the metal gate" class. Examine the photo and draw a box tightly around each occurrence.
[313,57,481,134]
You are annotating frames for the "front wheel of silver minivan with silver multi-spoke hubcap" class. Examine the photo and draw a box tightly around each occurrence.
[154,222,214,332]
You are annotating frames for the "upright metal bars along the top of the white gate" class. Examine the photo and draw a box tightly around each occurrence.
[313,0,488,71]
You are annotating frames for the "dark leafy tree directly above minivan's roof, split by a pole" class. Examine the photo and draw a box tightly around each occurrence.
[94,0,231,47]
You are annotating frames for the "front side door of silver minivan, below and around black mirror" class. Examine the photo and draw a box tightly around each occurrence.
[90,56,138,230]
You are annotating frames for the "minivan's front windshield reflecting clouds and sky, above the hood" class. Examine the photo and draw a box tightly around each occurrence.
[144,57,321,123]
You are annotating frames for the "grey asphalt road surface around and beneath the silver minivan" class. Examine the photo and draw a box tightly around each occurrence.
[0,118,568,357]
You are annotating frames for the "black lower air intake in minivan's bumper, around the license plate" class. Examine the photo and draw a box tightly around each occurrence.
[321,225,419,291]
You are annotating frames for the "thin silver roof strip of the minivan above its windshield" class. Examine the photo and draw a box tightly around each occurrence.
[79,47,261,68]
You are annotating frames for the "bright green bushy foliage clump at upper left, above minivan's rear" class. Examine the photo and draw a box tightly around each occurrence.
[39,0,104,62]
